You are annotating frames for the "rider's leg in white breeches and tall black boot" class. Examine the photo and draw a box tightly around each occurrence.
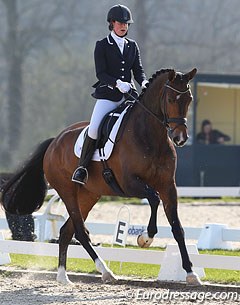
[72,99,122,184]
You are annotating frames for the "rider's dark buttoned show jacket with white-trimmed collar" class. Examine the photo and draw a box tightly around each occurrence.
[92,35,146,101]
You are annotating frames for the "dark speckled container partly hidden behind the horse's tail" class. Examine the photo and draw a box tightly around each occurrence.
[0,173,37,241]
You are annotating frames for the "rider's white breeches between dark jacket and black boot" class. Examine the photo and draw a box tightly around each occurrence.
[88,98,124,140]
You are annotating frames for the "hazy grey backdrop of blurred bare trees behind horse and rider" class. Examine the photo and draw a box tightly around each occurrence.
[0,0,240,169]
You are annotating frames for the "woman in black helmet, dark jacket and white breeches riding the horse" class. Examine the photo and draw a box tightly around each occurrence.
[72,5,147,184]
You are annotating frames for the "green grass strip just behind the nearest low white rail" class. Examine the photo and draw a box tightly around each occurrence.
[6,247,240,285]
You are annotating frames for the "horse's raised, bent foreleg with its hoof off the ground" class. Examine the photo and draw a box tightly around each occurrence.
[124,177,160,248]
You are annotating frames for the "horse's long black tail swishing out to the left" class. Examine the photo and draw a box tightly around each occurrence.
[0,138,54,215]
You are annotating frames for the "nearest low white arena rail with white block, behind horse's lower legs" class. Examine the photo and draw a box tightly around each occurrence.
[0,240,240,281]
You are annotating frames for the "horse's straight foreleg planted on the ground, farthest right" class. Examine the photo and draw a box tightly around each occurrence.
[161,185,201,285]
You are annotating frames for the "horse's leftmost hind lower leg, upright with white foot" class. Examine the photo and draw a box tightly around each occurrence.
[57,218,74,284]
